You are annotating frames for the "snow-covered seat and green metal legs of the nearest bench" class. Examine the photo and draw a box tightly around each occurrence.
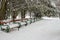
[1,23,21,32]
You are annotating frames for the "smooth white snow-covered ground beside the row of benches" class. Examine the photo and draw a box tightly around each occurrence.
[0,17,60,40]
